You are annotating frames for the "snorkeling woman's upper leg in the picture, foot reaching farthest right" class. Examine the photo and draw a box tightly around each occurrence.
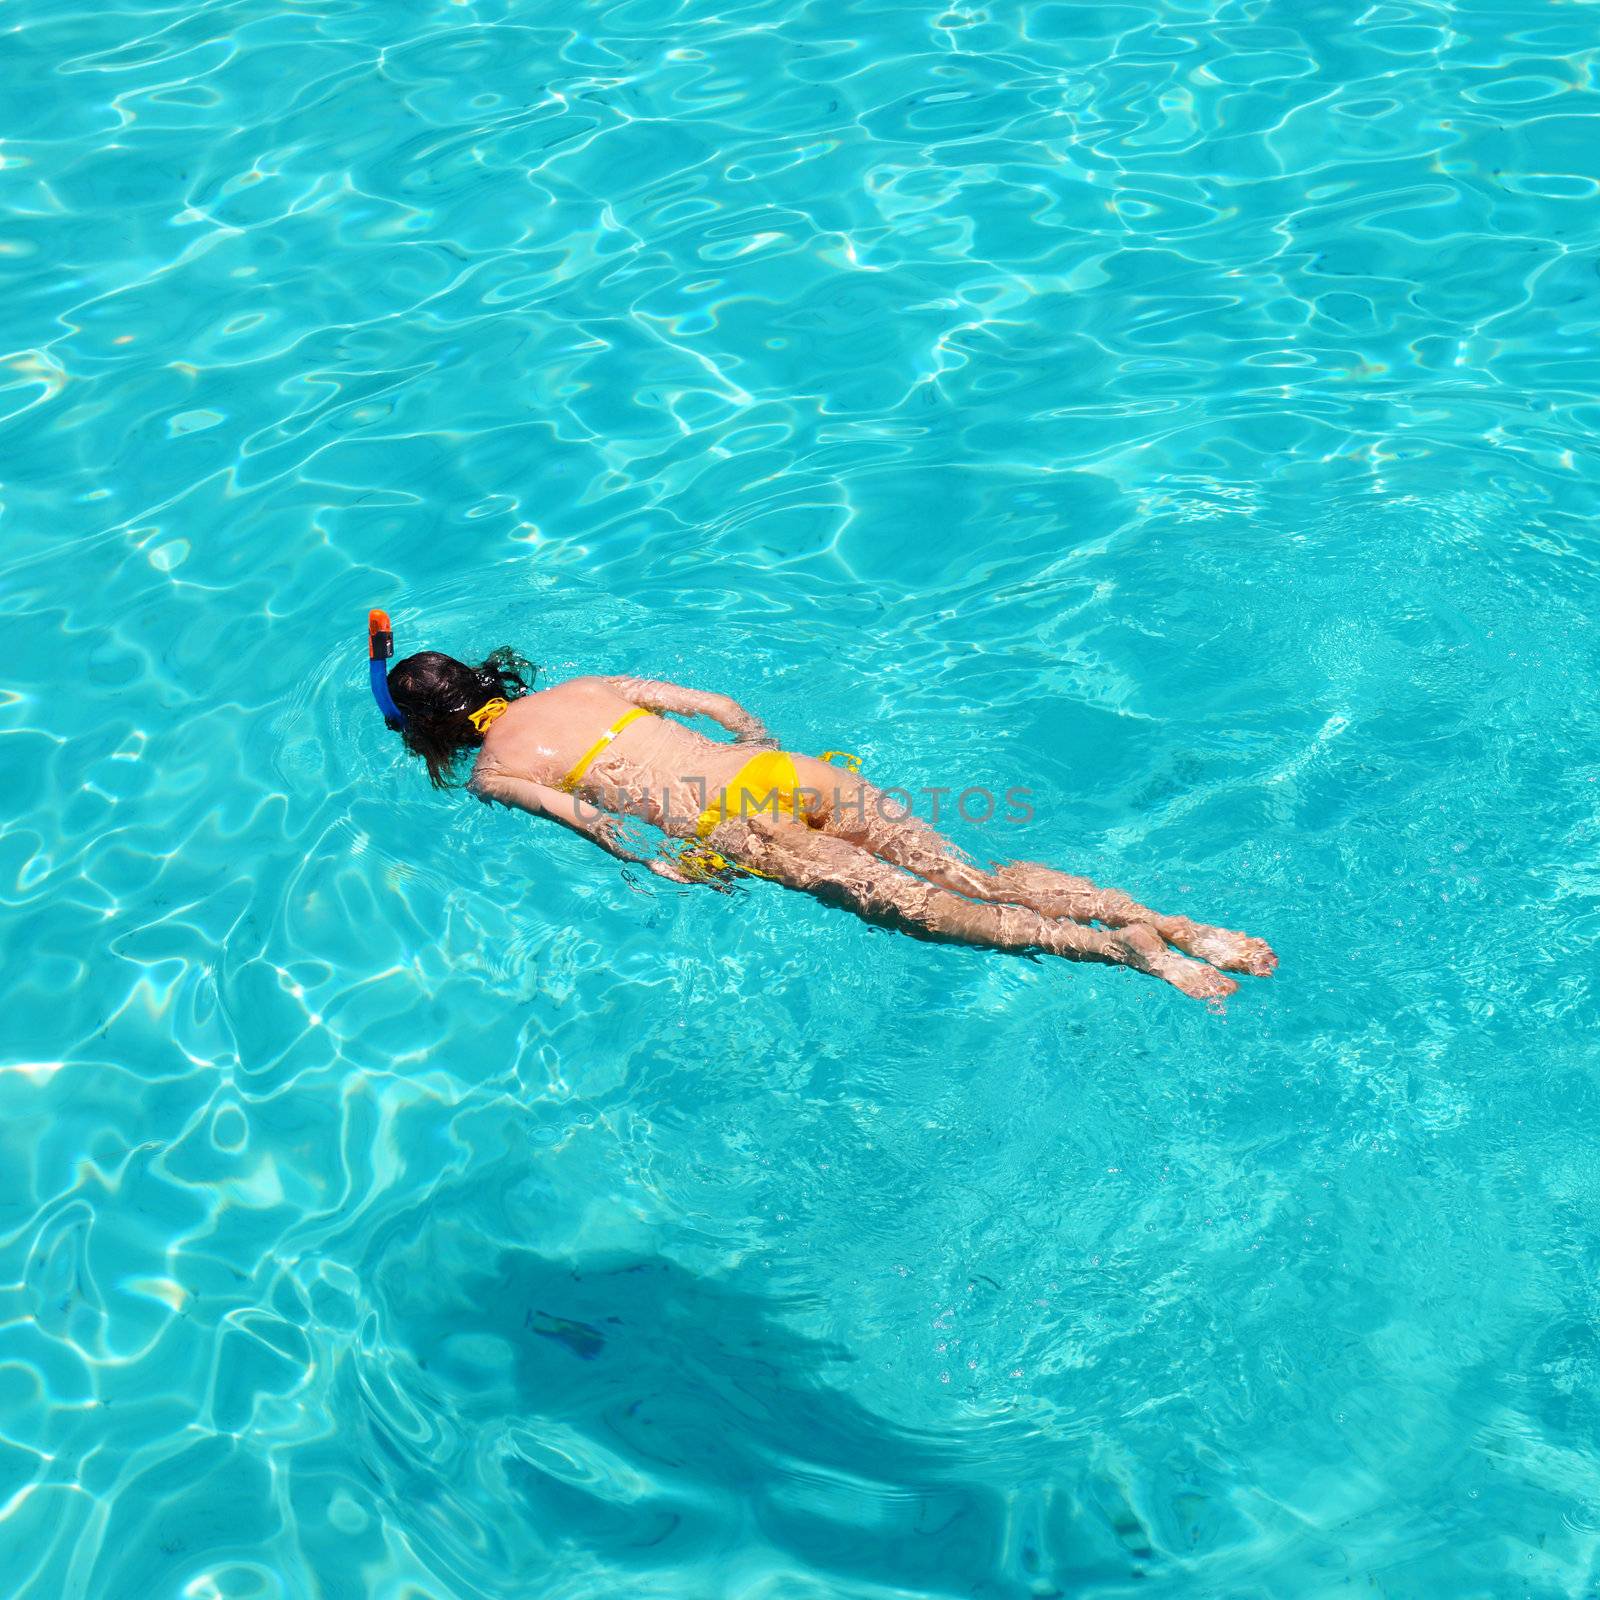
[797,758,1278,978]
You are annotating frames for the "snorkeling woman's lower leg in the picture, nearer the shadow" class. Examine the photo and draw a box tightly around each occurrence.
[726,816,1238,1000]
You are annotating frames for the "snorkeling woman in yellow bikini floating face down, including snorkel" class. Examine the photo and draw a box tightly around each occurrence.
[370,611,1277,1000]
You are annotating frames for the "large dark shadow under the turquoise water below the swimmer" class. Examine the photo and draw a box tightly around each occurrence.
[350,1248,1149,1600]
